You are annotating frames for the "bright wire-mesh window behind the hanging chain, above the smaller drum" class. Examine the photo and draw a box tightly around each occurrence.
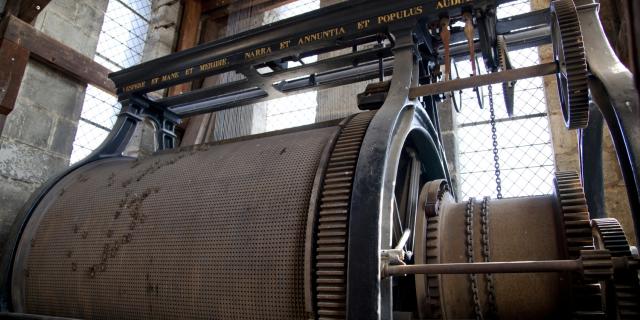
[453,0,554,198]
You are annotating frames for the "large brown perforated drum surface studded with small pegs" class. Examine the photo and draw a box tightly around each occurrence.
[13,127,338,319]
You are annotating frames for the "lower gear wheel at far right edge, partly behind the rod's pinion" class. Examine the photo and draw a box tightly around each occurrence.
[591,218,640,320]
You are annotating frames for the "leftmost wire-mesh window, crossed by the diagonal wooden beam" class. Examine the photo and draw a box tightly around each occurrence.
[71,0,151,163]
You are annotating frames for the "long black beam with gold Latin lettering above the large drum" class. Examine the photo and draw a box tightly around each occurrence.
[111,0,528,99]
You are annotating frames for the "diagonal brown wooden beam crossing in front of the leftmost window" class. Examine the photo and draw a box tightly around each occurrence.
[3,16,116,95]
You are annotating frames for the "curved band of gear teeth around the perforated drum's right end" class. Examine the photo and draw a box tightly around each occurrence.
[315,112,375,320]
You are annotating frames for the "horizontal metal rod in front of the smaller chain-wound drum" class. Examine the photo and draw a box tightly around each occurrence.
[384,260,582,276]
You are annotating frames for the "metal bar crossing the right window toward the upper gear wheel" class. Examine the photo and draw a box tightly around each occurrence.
[409,62,558,99]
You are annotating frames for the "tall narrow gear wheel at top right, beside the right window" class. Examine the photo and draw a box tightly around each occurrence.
[550,0,589,129]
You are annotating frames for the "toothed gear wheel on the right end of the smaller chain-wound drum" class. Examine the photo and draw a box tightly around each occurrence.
[554,171,605,319]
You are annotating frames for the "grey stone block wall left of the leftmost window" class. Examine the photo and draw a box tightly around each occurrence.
[0,0,108,248]
